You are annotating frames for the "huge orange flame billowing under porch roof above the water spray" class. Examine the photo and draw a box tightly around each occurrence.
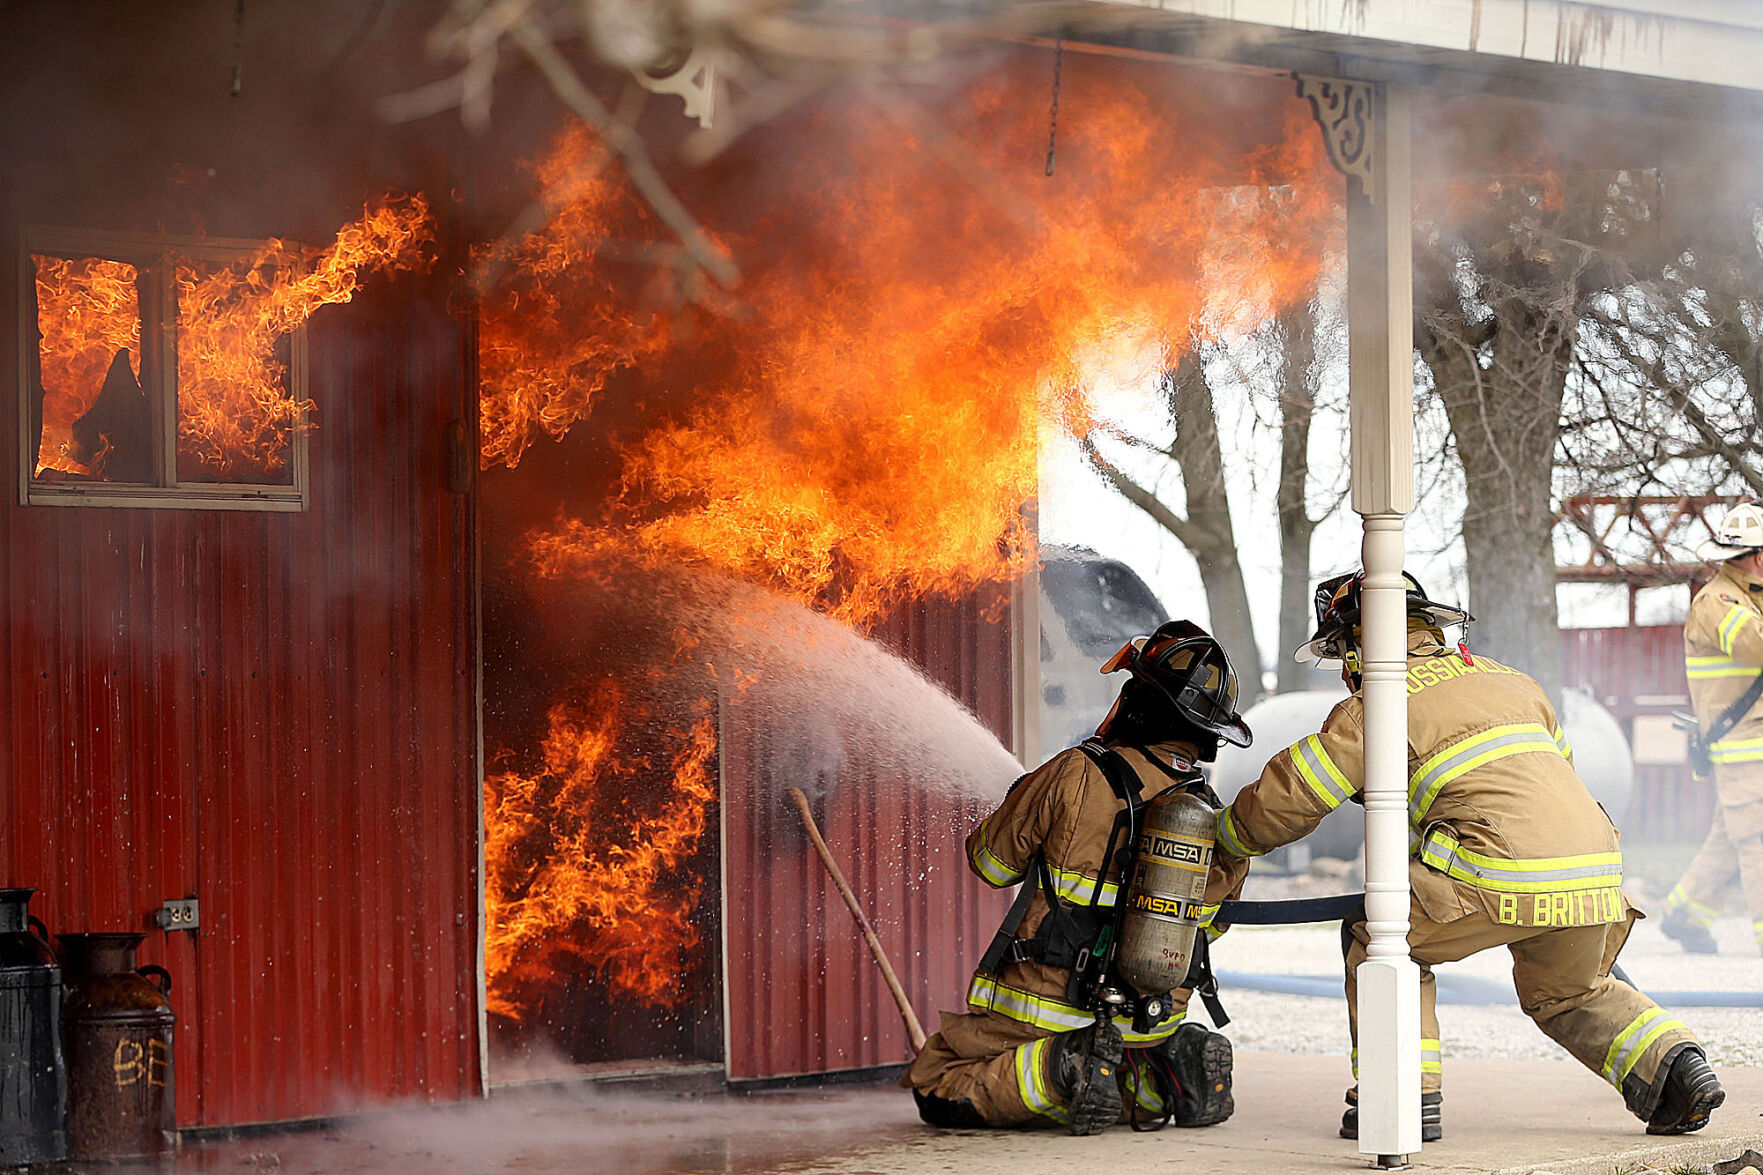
[481,62,1340,621]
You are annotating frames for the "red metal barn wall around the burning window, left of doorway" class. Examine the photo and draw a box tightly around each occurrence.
[0,4,480,1126]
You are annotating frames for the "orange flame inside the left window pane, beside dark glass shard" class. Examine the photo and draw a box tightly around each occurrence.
[30,254,141,476]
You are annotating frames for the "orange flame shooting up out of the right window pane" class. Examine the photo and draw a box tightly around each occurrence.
[173,196,434,482]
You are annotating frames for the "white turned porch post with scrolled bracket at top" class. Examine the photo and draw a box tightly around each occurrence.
[1299,78,1421,1166]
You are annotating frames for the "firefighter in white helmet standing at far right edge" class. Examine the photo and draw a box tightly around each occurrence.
[1661,503,1763,954]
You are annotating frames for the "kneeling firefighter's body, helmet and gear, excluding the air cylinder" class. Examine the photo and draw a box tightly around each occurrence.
[901,621,1250,1134]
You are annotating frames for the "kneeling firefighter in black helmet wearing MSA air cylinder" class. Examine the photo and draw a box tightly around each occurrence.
[901,621,1250,1134]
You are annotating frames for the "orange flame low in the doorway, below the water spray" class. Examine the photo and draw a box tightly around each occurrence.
[485,686,716,1020]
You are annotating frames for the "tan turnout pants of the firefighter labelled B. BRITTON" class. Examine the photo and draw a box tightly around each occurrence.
[1343,902,1696,1097]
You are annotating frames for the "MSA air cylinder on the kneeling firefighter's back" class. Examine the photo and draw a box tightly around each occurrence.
[1114,790,1216,995]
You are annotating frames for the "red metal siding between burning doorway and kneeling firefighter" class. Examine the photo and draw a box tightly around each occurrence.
[721,589,1010,1080]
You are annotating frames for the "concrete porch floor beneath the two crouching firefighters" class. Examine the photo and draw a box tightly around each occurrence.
[155,1052,1763,1175]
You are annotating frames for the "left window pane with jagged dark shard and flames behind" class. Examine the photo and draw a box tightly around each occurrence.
[30,254,153,482]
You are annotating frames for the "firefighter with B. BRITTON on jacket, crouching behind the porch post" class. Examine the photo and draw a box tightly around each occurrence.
[1213,573,1726,1141]
